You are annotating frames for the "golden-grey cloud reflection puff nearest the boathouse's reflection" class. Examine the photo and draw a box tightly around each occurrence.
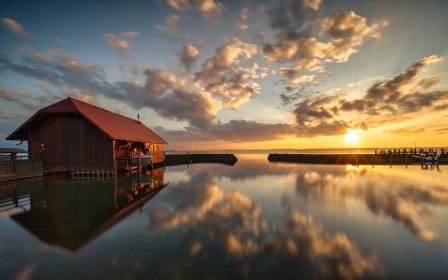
[149,173,265,255]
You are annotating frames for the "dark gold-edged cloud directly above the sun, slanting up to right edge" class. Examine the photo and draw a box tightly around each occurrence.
[290,55,448,137]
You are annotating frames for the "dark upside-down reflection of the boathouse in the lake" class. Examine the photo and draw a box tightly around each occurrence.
[11,168,164,251]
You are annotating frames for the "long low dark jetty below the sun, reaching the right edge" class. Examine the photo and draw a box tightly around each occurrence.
[268,149,448,165]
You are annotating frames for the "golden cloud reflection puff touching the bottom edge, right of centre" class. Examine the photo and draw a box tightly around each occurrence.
[263,211,381,279]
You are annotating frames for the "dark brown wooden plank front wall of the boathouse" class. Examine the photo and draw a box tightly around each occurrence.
[29,113,113,172]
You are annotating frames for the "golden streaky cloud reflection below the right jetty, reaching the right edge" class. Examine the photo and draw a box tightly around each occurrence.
[296,167,448,241]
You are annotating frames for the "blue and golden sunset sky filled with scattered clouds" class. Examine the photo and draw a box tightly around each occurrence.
[0,0,448,151]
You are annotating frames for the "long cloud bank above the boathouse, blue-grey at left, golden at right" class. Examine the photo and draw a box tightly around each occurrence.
[0,44,264,130]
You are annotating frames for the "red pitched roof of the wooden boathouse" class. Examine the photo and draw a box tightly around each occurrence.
[6,97,168,144]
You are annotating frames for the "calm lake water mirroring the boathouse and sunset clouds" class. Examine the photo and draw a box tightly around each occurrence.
[0,155,448,279]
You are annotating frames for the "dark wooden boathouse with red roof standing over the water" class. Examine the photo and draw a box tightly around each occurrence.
[6,97,167,173]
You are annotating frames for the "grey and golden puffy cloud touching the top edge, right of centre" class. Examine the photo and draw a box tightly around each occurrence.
[262,0,387,89]
